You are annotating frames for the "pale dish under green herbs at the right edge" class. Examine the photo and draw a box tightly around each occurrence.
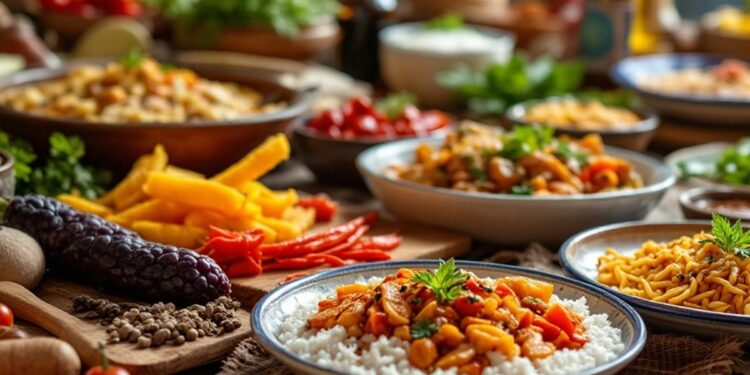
[664,142,750,191]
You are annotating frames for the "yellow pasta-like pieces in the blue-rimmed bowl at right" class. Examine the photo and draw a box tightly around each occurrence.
[597,233,750,315]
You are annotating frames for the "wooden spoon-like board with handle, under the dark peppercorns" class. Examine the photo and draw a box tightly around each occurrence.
[0,278,250,375]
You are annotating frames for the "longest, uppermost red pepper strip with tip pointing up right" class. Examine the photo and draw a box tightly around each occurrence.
[261,213,377,259]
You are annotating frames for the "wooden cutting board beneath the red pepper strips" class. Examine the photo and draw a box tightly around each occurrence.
[230,207,471,307]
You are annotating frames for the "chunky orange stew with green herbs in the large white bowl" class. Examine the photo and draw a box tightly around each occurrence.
[388,122,643,196]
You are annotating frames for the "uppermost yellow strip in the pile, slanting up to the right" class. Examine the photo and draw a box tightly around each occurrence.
[212,133,290,188]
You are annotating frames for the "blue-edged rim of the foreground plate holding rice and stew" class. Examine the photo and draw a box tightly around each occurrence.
[251,260,646,375]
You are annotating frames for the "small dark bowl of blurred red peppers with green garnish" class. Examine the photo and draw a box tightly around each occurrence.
[294,93,453,187]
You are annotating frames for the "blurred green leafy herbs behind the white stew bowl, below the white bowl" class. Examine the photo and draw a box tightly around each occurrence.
[437,54,584,115]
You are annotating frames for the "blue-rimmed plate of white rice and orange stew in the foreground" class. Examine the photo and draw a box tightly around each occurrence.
[252,261,645,374]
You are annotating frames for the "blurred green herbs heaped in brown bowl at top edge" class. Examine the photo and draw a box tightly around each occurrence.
[143,0,340,36]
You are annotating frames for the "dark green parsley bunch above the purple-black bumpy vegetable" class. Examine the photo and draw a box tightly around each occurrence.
[0,132,112,199]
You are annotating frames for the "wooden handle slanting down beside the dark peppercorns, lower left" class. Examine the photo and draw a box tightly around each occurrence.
[0,281,99,366]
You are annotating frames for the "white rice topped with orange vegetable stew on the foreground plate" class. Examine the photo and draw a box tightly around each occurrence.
[276,262,624,375]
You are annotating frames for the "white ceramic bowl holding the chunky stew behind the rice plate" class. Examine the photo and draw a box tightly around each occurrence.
[357,137,676,246]
